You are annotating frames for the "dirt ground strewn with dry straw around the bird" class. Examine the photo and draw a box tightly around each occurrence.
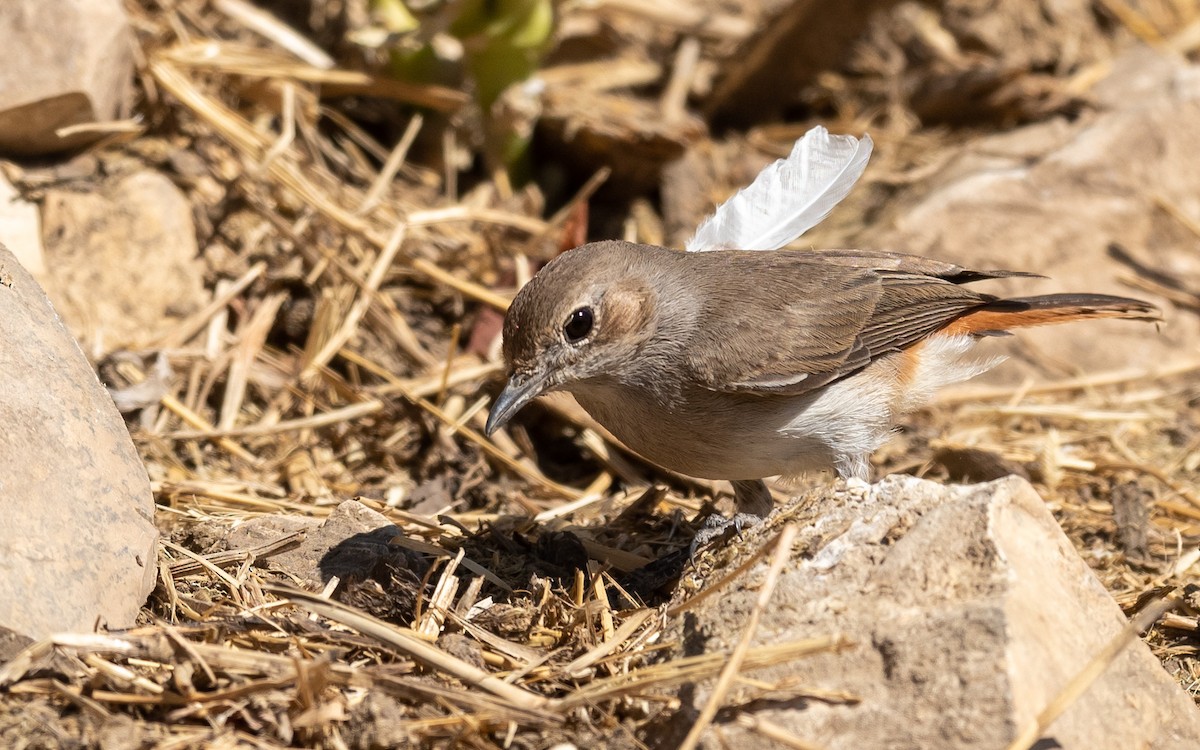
[0,0,1200,749]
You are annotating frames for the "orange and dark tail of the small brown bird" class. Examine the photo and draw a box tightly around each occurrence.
[942,294,1163,336]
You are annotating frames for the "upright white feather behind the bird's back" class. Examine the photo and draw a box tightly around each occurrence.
[688,126,872,252]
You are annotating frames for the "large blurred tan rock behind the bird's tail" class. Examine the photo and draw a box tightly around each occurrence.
[858,50,1200,382]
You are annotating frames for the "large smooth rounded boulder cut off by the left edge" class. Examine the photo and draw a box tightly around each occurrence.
[0,246,157,638]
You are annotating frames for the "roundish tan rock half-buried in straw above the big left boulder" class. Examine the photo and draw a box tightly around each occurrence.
[42,172,206,352]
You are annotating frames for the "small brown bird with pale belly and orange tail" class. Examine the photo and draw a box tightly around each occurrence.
[487,241,1160,522]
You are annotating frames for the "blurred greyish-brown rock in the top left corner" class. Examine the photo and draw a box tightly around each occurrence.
[0,0,133,155]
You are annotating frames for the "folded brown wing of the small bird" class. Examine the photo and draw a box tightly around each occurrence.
[689,252,995,395]
